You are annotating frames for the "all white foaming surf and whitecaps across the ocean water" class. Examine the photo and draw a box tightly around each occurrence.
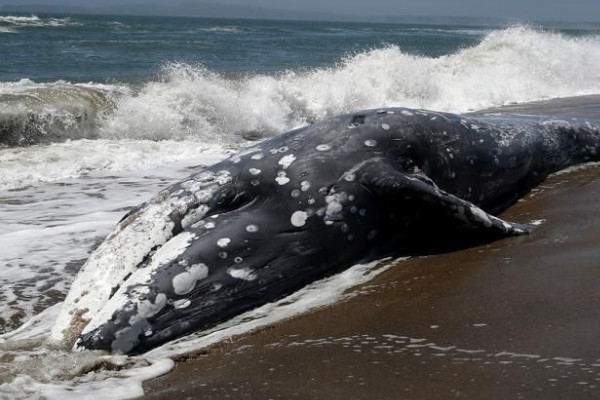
[0,16,600,399]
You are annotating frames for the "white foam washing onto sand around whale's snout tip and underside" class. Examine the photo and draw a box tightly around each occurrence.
[0,259,400,400]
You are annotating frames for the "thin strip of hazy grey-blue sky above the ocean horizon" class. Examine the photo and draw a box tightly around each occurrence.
[0,0,600,22]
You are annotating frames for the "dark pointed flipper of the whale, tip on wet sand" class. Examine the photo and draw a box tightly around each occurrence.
[360,158,533,236]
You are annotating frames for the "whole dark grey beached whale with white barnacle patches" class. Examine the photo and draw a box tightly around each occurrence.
[52,108,600,353]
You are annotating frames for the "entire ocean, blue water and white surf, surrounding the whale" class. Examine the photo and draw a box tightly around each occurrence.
[0,11,600,399]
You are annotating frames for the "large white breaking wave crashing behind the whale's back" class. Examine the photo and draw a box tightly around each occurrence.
[0,26,600,145]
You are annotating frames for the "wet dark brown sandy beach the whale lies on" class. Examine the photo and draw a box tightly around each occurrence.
[143,99,600,400]
